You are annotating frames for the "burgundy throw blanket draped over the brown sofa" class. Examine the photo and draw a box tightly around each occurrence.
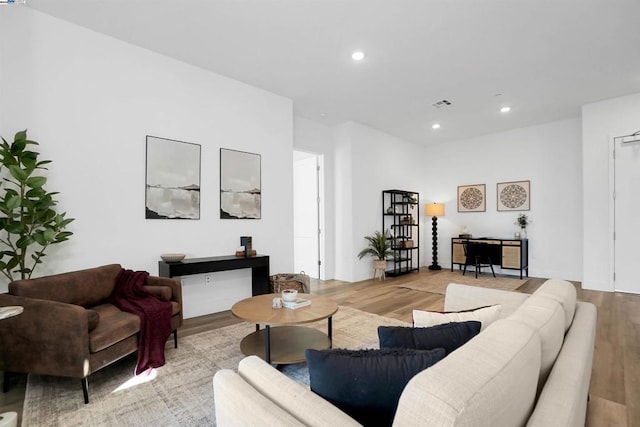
[109,269,171,375]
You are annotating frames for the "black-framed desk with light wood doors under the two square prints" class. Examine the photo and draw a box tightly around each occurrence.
[451,237,529,279]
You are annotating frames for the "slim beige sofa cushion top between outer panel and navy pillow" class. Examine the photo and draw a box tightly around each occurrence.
[238,356,361,427]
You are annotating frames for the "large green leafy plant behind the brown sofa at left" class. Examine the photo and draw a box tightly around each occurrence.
[0,130,73,280]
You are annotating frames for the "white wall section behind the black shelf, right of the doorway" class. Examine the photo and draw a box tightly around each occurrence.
[335,122,424,281]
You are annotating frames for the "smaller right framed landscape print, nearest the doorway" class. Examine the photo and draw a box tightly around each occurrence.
[220,148,262,219]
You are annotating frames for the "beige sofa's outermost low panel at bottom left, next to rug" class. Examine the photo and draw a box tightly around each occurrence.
[213,369,304,427]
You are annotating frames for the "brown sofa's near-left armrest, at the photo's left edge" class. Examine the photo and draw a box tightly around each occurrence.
[0,294,90,378]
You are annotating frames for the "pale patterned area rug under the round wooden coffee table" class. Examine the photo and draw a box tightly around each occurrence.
[22,307,407,427]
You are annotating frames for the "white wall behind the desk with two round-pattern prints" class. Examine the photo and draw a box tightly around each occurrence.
[423,119,582,280]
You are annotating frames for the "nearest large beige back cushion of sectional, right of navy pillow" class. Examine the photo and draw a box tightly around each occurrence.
[394,319,541,427]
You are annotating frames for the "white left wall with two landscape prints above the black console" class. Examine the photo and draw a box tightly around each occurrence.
[0,7,293,317]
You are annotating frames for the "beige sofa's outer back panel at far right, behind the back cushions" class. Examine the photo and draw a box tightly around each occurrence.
[527,302,597,427]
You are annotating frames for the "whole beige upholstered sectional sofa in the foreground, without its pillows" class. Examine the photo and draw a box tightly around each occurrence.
[213,279,596,427]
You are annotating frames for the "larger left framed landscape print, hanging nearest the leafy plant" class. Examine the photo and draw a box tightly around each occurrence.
[145,135,200,219]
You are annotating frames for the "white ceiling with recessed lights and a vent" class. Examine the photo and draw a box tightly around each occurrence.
[27,0,640,144]
